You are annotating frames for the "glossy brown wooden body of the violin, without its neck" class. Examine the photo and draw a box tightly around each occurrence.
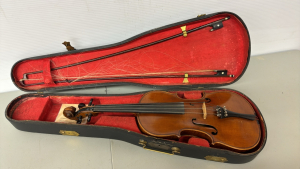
[137,91,261,152]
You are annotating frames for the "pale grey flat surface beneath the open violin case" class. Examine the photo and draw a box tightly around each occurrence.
[0,51,300,169]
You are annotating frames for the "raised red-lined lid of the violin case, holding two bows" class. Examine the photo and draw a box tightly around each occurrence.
[11,12,250,92]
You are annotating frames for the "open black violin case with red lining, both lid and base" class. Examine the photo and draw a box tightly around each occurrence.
[5,12,267,164]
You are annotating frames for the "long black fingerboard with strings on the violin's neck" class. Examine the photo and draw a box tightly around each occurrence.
[89,102,184,114]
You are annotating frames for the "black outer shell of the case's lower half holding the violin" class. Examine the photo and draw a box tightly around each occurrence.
[5,89,267,164]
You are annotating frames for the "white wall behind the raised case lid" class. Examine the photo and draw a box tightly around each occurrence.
[0,0,300,92]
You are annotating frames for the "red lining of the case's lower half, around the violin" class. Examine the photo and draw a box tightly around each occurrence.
[7,89,265,153]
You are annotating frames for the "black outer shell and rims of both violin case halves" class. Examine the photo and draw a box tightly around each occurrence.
[5,12,267,164]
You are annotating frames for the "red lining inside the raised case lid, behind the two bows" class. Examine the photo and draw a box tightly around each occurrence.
[12,14,249,90]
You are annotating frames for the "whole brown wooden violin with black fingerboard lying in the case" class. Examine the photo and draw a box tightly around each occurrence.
[63,91,261,152]
